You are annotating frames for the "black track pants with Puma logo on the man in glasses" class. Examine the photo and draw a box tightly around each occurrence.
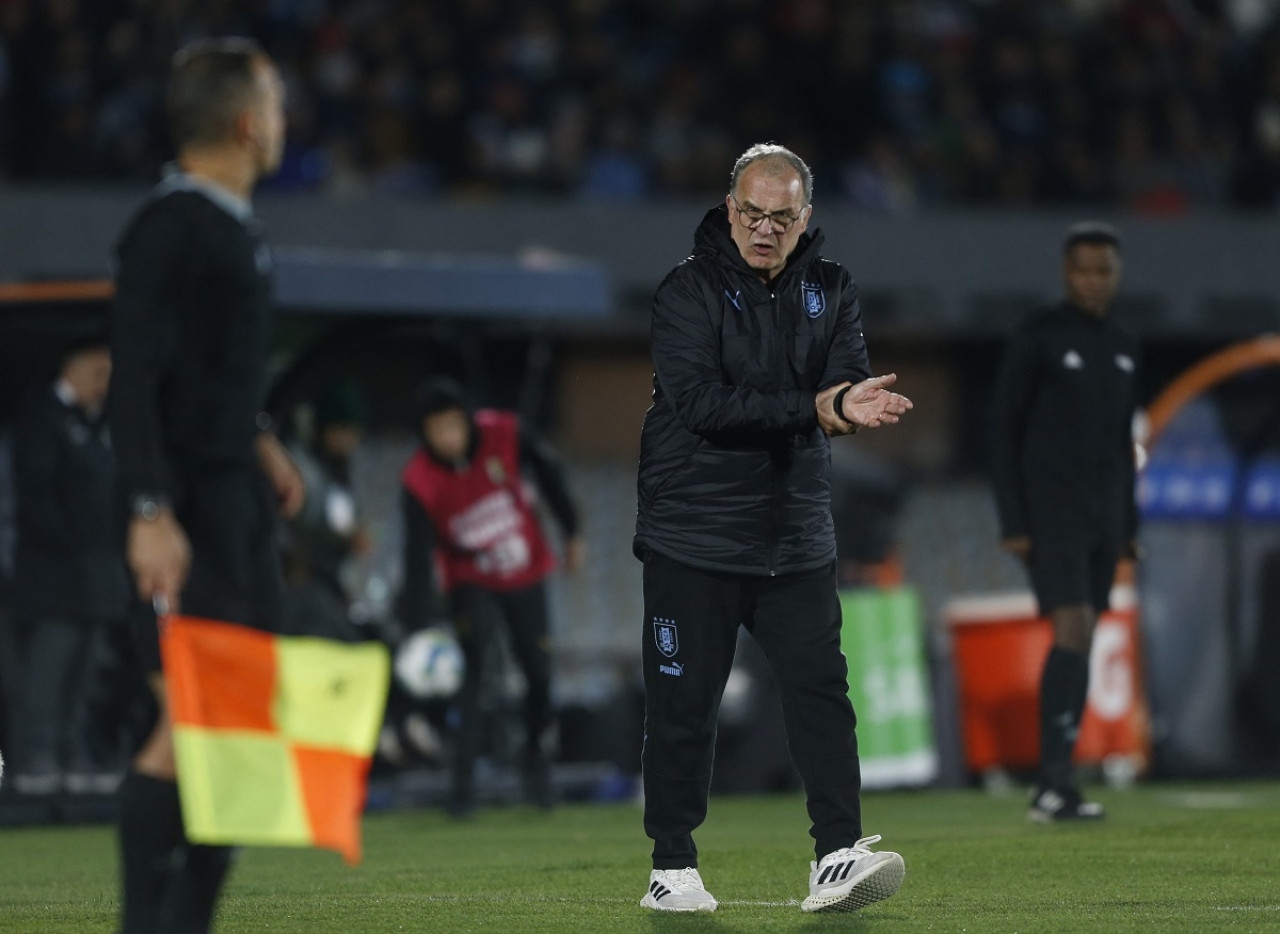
[643,554,861,869]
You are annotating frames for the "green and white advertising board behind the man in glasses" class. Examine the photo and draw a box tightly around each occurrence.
[840,587,938,788]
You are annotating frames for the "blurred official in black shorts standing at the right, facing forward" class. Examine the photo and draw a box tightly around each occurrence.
[991,223,1140,821]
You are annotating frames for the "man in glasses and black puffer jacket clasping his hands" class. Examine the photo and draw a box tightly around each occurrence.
[635,143,910,911]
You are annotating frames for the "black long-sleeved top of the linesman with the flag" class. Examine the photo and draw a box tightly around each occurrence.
[110,186,271,498]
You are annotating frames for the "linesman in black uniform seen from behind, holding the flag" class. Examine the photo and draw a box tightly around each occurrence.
[109,40,303,934]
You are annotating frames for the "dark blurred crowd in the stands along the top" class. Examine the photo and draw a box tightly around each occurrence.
[0,0,1280,214]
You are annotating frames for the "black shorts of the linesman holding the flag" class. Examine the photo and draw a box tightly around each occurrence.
[131,468,282,672]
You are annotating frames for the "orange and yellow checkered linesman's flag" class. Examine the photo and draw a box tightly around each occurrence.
[160,615,390,865]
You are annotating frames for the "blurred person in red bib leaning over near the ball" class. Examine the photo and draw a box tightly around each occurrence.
[401,379,585,816]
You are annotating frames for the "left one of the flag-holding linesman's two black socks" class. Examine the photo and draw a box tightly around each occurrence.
[120,772,183,934]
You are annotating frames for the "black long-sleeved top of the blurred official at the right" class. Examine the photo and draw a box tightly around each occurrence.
[991,303,1140,542]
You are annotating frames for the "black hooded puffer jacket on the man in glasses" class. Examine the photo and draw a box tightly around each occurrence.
[635,207,870,574]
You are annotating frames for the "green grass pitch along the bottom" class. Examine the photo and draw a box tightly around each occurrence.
[0,783,1280,934]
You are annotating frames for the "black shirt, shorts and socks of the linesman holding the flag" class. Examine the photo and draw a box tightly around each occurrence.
[109,174,280,934]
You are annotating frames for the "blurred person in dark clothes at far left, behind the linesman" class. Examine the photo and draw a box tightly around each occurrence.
[13,340,128,793]
